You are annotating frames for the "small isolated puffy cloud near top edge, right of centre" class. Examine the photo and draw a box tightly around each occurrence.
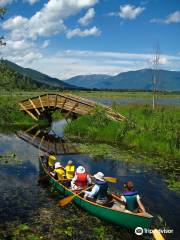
[108,4,145,20]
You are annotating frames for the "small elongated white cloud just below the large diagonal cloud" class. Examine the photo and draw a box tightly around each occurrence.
[66,26,101,39]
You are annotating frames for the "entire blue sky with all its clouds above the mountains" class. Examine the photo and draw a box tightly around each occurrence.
[0,0,180,79]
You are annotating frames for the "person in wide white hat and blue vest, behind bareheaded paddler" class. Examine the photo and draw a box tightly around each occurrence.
[84,172,108,205]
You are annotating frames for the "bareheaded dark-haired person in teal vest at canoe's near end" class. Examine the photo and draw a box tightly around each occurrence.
[112,181,146,213]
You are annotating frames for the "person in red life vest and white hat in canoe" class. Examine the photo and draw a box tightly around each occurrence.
[71,166,91,190]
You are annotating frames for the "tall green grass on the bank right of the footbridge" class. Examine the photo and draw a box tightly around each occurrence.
[65,105,180,158]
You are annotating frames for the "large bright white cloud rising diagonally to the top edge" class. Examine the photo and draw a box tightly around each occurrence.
[3,0,97,40]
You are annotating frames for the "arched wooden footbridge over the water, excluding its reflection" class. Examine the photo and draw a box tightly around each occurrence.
[19,93,126,121]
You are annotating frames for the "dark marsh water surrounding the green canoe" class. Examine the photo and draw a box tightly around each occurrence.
[0,120,180,240]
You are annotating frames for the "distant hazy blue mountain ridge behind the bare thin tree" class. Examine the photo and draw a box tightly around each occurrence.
[65,69,180,91]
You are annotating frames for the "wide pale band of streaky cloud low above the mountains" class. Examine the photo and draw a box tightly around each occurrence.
[2,47,180,79]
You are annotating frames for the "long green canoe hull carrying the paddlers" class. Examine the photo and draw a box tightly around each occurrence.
[40,157,153,229]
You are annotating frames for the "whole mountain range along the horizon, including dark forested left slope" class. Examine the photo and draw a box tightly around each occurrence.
[0,60,180,91]
